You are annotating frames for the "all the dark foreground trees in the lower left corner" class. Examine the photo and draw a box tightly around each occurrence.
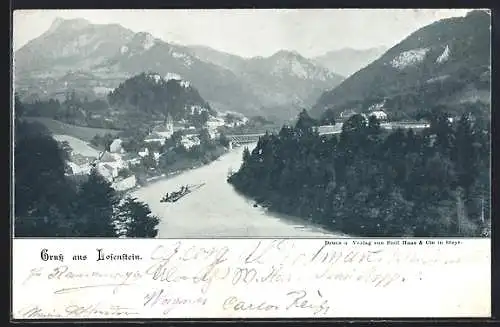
[14,99,159,237]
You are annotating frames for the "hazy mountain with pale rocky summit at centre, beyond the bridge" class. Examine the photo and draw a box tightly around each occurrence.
[186,46,343,117]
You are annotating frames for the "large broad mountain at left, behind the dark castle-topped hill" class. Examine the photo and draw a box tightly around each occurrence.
[14,19,261,118]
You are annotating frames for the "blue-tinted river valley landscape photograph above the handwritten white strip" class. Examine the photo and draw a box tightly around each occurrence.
[12,9,491,238]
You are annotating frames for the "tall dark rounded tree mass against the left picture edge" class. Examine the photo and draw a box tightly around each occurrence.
[14,123,75,237]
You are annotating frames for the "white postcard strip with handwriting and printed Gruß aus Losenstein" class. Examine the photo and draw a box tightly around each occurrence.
[12,238,491,319]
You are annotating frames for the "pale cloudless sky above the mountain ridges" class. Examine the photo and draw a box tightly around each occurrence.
[13,9,470,57]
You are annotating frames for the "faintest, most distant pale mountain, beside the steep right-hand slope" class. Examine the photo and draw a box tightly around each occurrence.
[312,47,387,76]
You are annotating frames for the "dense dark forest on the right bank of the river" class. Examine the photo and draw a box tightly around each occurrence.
[228,110,490,237]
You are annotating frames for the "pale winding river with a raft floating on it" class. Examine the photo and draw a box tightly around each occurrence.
[133,144,342,238]
